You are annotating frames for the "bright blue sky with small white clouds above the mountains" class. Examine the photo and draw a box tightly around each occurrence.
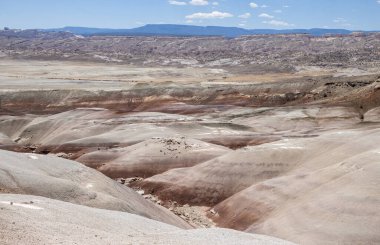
[0,0,380,30]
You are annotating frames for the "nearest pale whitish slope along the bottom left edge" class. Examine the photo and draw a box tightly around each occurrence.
[0,194,293,245]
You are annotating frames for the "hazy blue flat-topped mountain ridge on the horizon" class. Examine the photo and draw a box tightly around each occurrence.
[43,24,374,38]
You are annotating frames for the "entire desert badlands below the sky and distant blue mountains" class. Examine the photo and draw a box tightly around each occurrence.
[0,30,380,244]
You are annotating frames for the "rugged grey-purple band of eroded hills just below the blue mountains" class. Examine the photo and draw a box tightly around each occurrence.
[0,30,380,73]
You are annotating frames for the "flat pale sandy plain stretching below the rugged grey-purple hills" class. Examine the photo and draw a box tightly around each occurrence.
[0,59,380,90]
